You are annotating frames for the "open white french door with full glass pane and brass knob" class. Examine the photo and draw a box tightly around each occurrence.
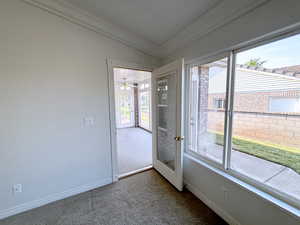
[152,60,184,191]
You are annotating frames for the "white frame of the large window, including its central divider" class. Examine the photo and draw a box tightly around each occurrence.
[185,29,300,211]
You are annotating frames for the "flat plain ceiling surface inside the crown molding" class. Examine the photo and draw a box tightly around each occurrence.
[67,0,222,45]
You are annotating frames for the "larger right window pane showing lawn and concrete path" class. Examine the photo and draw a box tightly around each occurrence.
[231,35,300,200]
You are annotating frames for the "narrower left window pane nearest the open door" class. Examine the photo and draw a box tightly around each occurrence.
[188,58,227,163]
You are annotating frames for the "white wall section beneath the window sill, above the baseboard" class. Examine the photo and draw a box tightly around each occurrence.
[184,157,300,225]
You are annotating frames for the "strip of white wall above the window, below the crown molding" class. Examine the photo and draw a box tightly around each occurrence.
[165,0,300,62]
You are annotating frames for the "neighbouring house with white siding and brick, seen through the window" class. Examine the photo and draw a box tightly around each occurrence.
[208,62,300,114]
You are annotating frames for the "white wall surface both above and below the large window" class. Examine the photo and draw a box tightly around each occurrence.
[165,0,300,225]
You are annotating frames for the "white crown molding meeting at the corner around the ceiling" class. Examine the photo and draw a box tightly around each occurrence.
[21,0,270,59]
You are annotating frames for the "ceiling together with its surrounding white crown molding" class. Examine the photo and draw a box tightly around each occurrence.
[26,0,268,57]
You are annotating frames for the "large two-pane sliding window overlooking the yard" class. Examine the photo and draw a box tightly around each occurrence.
[188,32,300,207]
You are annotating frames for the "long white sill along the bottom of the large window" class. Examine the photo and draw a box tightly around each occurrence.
[184,152,300,219]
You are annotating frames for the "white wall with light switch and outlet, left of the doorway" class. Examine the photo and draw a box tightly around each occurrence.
[0,0,156,217]
